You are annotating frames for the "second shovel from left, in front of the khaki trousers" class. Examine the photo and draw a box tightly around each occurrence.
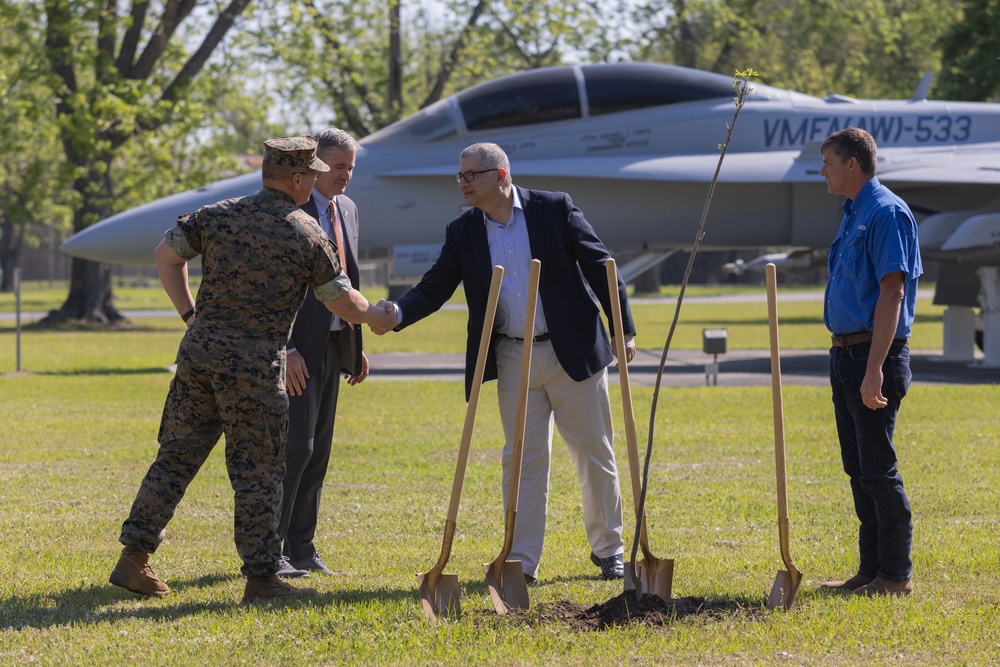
[483,259,542,615]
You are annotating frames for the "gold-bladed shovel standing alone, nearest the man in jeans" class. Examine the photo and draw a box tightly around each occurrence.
[764,264,802,609]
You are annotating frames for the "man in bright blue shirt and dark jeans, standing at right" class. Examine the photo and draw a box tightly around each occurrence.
[820,127,923,595]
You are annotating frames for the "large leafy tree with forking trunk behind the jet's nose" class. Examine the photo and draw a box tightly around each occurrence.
[44,0,250,324]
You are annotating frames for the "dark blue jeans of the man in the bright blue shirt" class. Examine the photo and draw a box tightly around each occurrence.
[830,342,913,581]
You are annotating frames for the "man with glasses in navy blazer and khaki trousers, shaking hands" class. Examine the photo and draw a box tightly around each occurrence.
[373,143,635,583]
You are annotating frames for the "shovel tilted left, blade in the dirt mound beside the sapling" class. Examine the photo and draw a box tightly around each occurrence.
[604,259,674,600]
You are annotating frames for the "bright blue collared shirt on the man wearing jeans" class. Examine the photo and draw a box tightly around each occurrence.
[823,178,924,338]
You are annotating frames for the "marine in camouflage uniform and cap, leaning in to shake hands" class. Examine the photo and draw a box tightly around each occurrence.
[112,137,386,595]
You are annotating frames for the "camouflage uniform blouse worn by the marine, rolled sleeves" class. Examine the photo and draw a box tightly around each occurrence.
[165,188,351,391]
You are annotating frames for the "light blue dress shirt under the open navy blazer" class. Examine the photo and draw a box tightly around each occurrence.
[483,189,549,338]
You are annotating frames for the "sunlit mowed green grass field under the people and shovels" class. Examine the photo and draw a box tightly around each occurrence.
[0,282,1000,665]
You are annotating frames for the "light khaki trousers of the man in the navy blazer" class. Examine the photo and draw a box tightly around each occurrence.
[497,337,624,577]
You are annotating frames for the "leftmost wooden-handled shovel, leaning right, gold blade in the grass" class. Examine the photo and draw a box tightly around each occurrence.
[417,266,503,621]
